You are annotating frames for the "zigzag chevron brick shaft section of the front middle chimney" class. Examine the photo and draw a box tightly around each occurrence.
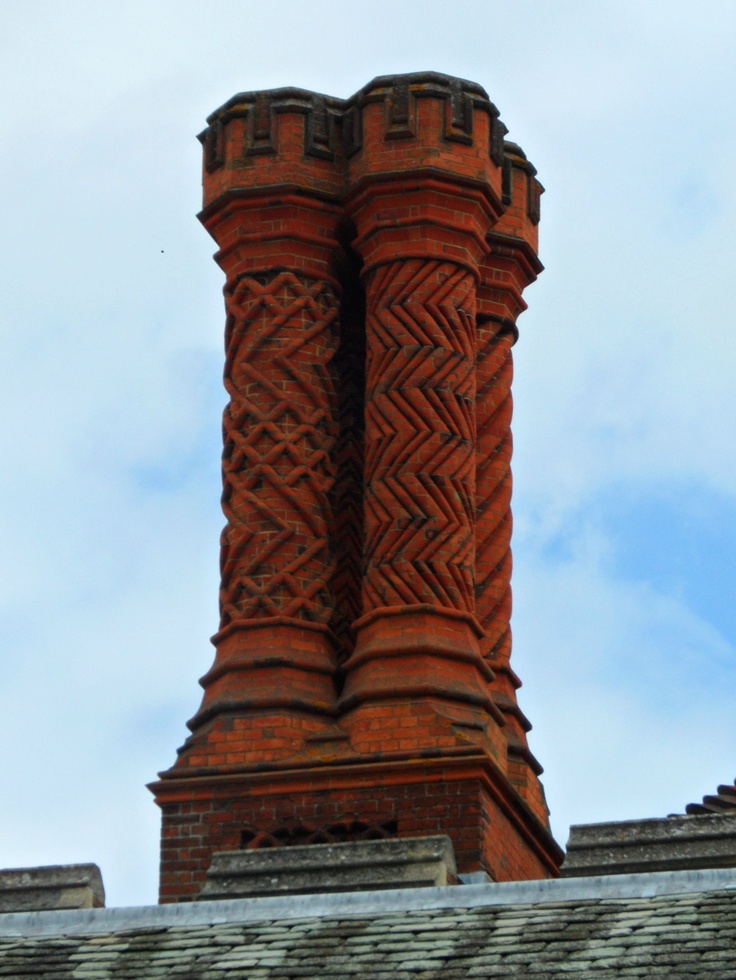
[363,259,475,613]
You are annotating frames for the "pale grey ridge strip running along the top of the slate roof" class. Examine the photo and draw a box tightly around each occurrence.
[0,868,736,937]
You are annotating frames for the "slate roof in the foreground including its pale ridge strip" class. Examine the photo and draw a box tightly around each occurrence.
[0,869,736,980]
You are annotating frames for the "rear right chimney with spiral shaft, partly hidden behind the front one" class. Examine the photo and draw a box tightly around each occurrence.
[476,143,546,820]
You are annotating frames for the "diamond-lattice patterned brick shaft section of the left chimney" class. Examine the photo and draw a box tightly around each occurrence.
[220,271,337,630]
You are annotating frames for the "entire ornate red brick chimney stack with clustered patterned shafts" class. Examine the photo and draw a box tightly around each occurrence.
[151,72,562,902]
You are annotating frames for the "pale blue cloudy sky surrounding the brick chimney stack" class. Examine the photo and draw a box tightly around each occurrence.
[0,0,736,905]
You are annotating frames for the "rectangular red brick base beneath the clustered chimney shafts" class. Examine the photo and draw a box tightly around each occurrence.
[155,753,559,902]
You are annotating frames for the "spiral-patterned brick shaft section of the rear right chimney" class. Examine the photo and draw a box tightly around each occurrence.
[475,319,514,661]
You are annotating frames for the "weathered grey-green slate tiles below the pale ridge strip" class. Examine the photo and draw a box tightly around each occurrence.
[0,891,736,980]
